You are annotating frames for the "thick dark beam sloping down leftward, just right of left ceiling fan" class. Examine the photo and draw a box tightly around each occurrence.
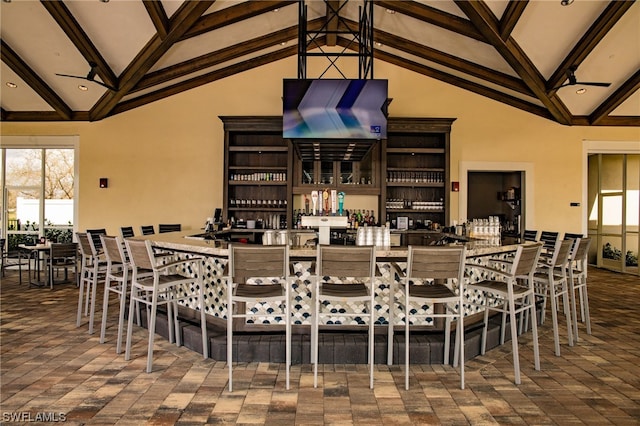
[89,0,214,120]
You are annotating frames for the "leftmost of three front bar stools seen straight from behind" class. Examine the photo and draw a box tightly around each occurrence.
[227,244,291,392]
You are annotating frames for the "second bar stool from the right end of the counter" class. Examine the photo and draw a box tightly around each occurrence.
[533,240,573,356]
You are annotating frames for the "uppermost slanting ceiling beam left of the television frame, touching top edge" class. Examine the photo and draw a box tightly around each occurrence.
[180,0,298,41]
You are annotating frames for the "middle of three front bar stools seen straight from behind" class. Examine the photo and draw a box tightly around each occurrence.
[311,245,376,389]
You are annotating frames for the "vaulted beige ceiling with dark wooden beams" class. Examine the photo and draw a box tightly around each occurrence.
[0,0,640,126]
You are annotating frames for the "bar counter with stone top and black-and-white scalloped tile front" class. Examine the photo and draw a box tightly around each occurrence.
[135,230,517,330]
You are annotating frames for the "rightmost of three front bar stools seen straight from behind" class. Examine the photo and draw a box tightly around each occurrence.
[400,246,466,390]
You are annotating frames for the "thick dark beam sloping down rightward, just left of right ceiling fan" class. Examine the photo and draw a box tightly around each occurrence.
[455,0,572,125]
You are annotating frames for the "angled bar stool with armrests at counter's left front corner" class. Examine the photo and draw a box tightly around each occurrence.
[124,239,209,373]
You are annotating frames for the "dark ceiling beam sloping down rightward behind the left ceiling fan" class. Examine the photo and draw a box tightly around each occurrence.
[40,0,118,87]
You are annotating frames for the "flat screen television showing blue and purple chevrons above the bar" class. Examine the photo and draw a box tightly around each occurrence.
[282,79,388,140]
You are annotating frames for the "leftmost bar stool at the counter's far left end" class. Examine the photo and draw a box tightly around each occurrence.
[76,232,107,334]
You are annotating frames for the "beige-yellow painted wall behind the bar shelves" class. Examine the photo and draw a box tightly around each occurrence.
[1,58,640,234]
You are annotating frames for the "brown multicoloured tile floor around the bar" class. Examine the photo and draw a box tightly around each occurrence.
[0,269,640,425]
